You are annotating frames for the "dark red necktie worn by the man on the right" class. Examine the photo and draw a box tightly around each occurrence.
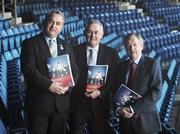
[127,62,137,88]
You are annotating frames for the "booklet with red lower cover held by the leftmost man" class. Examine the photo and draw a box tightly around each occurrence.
[47,54,74,87]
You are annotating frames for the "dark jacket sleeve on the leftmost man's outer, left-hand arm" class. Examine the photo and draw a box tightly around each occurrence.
[20,40,52,90]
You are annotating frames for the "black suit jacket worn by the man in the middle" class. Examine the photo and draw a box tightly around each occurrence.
[71,43,119,121]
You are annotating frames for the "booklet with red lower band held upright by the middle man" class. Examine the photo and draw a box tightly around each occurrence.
[86,65,108,90]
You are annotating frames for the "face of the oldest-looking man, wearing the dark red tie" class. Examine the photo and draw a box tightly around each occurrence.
[125,36,143,60]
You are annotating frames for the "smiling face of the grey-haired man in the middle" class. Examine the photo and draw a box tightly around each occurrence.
[86,23,104,47]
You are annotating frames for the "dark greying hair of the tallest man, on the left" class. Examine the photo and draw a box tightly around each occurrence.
[43,10,65,27]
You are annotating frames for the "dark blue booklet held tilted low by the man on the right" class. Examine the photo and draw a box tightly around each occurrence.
[113,84,141,107]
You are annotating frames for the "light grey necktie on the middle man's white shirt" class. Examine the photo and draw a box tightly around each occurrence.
[88,49,97,65]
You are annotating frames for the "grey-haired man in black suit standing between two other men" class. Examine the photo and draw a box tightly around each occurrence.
[70,20,119,134]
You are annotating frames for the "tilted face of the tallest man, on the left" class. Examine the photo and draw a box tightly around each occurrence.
[45,13,64,38]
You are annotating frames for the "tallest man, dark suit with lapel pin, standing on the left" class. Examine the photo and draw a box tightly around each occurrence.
[21,10,78,134]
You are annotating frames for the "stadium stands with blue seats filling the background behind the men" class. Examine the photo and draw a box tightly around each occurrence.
[0,0,180,134]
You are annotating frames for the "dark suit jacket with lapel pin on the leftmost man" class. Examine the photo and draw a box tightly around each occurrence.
[21,33,78,113]
